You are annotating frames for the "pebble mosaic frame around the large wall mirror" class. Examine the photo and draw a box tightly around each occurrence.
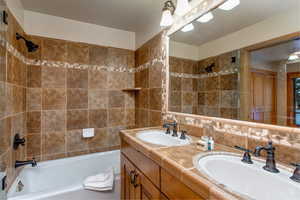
[162,0,300,134]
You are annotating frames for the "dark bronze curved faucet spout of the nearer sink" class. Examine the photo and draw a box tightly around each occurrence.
[254,141,279,173]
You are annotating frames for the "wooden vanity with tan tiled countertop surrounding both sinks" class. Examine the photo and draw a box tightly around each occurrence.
[121,128,241,200]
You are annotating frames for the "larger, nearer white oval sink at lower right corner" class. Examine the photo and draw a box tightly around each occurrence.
[194,153,300,200]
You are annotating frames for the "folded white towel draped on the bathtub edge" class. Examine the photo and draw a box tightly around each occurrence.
[83,168,114,191]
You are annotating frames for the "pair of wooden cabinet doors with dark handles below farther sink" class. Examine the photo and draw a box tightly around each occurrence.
[121,156,160,200]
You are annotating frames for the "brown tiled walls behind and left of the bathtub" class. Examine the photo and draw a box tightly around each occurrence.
[0,5,135,189]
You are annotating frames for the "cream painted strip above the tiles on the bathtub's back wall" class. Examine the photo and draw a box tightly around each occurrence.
[24,10,135,50]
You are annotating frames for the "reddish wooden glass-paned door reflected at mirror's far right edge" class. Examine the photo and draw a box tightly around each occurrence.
[287,72,300,127]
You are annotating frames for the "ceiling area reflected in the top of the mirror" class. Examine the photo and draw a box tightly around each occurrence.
[171,0,300,46]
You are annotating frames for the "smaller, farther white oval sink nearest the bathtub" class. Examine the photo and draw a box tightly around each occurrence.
[137,130,191,146]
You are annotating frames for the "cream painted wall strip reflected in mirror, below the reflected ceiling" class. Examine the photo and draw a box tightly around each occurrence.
[199,9,300,60]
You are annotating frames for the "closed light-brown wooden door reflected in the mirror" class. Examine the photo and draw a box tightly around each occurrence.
[250,70,277,124]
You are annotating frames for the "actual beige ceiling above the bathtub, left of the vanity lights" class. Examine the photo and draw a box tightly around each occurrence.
[21,0,165,32]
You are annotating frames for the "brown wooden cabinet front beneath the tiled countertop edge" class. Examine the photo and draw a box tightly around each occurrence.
[121,140,204,200]
